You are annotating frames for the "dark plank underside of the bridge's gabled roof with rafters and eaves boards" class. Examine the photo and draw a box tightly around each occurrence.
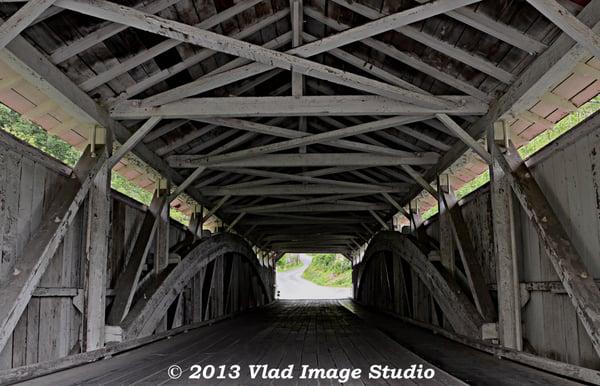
[0,0,600,252]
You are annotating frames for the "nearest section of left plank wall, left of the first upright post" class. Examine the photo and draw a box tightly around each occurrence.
[0,143,84,369]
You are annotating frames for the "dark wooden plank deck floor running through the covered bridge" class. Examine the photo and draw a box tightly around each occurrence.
[18,300,580,385]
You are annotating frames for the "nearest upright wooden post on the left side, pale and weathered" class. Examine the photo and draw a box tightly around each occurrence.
[82,127,112,351]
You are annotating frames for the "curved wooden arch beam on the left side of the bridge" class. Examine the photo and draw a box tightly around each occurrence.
[122,233,273,339]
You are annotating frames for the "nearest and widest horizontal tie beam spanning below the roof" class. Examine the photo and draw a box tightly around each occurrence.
[111,95,487,119]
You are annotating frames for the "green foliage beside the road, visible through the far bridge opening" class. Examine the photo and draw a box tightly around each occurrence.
[302,253,352,287]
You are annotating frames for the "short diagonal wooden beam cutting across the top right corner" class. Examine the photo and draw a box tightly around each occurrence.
[527,0,600,58]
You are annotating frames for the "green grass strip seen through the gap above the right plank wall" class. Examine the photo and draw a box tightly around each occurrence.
[423,96,600,220]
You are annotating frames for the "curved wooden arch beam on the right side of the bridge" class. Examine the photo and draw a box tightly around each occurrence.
[356,231,483,338]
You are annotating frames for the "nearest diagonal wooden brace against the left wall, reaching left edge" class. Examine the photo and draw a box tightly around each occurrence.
[0,148,107,349]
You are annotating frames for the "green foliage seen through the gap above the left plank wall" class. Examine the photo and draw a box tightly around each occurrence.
[0,104,189,224]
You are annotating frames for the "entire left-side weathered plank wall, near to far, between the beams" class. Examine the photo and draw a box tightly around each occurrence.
[0,141,184,369]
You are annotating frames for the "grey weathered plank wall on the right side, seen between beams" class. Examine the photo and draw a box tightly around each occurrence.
[427,117,600,369]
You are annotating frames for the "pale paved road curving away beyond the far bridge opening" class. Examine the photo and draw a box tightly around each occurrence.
[277,254,352,299]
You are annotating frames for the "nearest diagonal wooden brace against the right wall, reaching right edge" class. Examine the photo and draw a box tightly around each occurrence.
[495,145,600,355]
